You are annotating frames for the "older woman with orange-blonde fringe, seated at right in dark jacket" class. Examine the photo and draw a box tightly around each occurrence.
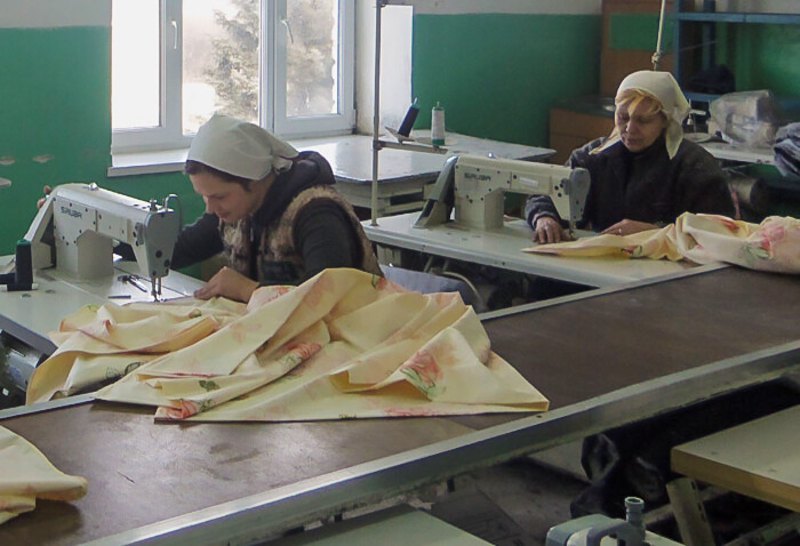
[525,70,734,243]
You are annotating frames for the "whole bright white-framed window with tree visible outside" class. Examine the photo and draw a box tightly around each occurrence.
[111,0,355,152]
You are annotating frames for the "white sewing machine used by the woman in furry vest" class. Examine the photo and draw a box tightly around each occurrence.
[25,183,181,299]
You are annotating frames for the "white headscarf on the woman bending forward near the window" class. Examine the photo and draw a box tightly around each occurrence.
[186,114,297,180]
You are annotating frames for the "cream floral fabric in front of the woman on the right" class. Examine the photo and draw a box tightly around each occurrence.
[523,212,800,273]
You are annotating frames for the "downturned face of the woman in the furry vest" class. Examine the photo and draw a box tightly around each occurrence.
[189,171,263,224]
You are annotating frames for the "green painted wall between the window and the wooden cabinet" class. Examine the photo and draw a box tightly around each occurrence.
[412,14,600,146]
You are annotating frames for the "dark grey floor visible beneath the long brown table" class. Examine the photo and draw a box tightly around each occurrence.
[296,434,800,546]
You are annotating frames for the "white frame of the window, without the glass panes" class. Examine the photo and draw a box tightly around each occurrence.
[111,0,356,155]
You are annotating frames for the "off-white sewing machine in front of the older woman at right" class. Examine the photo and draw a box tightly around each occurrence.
[415,154,590,231]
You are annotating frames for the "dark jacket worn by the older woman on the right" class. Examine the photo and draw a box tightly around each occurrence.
[525,137,734,231]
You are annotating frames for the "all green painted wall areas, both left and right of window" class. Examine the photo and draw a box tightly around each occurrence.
[0,14,800,254]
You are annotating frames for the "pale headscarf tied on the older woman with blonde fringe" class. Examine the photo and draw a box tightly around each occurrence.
[592,70,691,159]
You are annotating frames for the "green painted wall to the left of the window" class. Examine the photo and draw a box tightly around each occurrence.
[0,27,202,255]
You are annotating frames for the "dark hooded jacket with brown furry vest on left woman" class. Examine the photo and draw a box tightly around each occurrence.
[172,152,379,285]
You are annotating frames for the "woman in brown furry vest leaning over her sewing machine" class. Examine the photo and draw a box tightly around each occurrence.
[172,115,381,301]
